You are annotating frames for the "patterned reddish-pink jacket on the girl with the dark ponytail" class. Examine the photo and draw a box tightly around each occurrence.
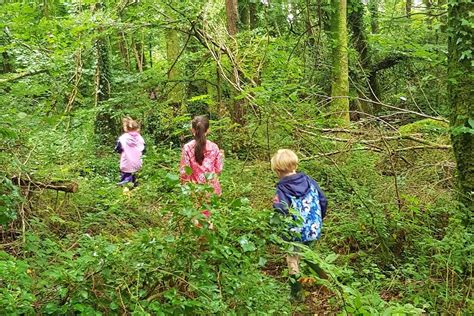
[179,140,224,195]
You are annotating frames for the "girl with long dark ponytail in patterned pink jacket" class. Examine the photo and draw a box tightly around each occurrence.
[180,115,224,195]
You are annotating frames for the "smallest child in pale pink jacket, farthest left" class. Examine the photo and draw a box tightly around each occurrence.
[115,117,145,187]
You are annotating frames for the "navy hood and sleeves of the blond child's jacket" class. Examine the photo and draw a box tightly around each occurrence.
[273,172,328,218]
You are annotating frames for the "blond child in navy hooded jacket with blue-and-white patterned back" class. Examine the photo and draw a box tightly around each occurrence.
[271,149,328,297]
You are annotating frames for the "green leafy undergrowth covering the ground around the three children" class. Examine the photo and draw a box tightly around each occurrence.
[0,111,473,315]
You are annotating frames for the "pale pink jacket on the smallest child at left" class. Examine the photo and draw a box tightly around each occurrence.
[118,132,145,173]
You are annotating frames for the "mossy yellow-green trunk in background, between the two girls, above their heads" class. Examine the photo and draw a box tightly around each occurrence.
[166,29,185,106]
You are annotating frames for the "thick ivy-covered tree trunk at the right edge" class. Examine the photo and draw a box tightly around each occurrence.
[448,0,474,212]
